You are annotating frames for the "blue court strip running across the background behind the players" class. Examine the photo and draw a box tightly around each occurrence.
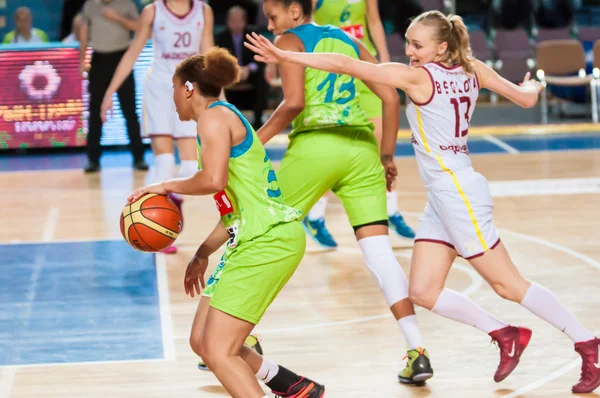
[0,133,600,172]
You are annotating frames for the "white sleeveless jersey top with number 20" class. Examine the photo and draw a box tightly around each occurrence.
[148,0,204,86]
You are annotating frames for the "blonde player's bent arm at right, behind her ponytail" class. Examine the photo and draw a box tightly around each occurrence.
[474,60,544,108]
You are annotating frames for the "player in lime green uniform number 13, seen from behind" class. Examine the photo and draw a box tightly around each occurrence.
[246,0,433,384]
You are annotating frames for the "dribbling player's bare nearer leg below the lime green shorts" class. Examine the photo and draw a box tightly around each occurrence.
[200,307,265,398]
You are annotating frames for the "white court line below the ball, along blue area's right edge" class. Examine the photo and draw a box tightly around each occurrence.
[155,253,175,361]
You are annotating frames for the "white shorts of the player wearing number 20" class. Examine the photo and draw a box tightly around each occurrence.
[142,81,196,138]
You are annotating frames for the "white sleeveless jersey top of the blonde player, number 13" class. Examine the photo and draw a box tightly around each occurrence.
[406,63,479,189]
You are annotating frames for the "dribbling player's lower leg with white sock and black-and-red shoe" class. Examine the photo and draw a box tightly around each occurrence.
[241,346,325,398]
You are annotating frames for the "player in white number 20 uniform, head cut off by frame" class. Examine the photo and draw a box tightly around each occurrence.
[100,0,214,253]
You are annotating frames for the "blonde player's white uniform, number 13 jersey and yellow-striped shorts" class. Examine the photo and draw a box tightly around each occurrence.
[406,63,499,259]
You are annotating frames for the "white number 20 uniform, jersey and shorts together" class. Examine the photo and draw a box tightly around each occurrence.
[143,0,204,138]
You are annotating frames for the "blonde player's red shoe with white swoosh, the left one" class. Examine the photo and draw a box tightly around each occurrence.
[490,326,531,383]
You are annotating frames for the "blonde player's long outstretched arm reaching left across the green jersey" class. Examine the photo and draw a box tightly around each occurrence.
[244,33,426,91]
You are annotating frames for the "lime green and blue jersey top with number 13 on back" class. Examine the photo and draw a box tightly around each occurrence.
[286,24,374,135]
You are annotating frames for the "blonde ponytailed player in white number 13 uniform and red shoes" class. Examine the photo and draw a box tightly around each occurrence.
[247,11,600,393]
